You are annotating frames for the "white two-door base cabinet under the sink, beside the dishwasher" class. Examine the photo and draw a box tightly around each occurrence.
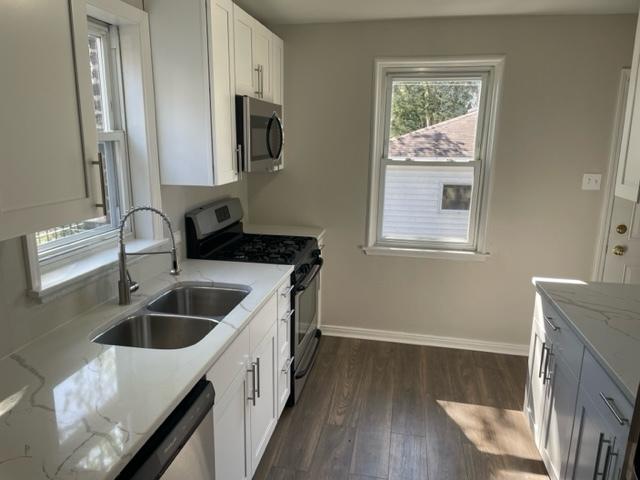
[207,281,288,480]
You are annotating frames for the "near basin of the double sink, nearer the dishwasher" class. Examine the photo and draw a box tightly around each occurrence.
[93,313,218,350]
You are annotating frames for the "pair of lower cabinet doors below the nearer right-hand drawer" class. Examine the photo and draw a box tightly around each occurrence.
[566,388,626,480]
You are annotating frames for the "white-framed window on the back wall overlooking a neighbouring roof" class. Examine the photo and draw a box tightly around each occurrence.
[365,58,502,253]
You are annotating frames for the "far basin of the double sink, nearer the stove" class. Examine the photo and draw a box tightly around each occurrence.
[146,283,250,320]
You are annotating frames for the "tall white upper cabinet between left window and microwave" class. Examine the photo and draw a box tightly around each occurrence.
[145,0,238,186]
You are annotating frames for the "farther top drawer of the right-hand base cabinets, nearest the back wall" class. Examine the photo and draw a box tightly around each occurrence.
[541,298,584,377]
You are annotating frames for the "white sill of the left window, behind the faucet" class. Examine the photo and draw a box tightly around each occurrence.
[29,239,172,303]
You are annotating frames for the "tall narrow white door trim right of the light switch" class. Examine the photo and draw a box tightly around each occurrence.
[591,67,631,282]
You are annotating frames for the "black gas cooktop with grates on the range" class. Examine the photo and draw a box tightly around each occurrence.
[207,233,317,265]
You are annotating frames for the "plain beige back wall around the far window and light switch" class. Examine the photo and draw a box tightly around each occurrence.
[249,16,636,344]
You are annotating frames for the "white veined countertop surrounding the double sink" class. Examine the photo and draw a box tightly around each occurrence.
[0,260,292,480]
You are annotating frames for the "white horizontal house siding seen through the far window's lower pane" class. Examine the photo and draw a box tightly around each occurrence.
[382,166,473,241]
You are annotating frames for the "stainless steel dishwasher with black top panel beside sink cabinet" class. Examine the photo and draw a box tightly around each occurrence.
[117,379,215,480]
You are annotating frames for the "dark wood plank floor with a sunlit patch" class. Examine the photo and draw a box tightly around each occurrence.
[254,337,548,480]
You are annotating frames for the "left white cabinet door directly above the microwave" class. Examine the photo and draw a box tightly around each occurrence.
[233,5,258,97]
